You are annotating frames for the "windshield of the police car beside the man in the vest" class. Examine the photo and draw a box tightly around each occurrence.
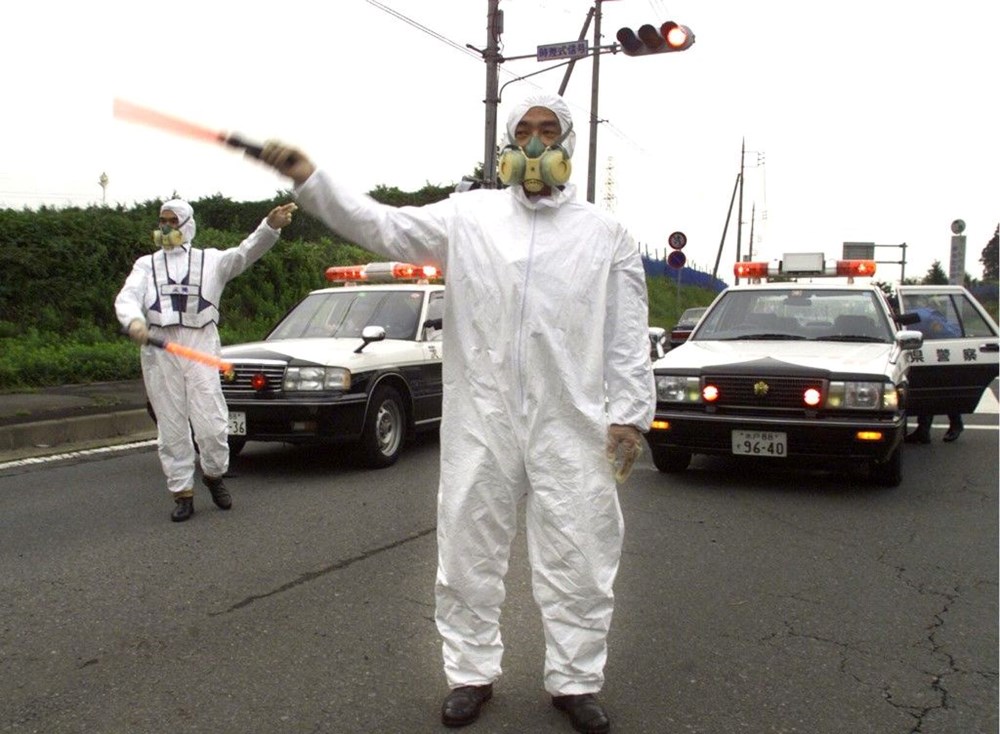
[267,288,423,341]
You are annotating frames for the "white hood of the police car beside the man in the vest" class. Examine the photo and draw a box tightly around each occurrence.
[222,338,416,368]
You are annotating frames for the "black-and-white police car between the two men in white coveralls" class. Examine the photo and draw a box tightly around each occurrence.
[222,263,445,468]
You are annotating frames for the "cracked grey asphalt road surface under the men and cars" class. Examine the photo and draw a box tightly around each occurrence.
[0,426,1000,734]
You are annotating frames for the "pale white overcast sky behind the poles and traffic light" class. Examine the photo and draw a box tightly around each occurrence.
[0,0,1000,282]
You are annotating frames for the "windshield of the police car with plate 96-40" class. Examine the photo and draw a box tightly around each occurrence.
[693,288,894,343]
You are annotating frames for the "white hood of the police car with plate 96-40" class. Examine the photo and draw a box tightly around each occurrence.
[653,340,894,374]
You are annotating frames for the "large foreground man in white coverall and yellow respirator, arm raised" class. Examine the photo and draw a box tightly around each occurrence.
[254,95,655,732]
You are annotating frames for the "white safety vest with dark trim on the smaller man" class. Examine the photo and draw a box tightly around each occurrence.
[147,247,219,329]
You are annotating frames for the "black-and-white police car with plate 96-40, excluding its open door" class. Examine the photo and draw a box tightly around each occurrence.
[646,253,922,486]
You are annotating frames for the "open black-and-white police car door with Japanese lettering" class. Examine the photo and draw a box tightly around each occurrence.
[897,285,1000,415]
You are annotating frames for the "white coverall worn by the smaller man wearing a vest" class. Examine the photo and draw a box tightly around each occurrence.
[115,199,280,494]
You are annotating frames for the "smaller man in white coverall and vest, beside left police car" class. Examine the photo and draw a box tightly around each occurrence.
[115,199,296,522]
